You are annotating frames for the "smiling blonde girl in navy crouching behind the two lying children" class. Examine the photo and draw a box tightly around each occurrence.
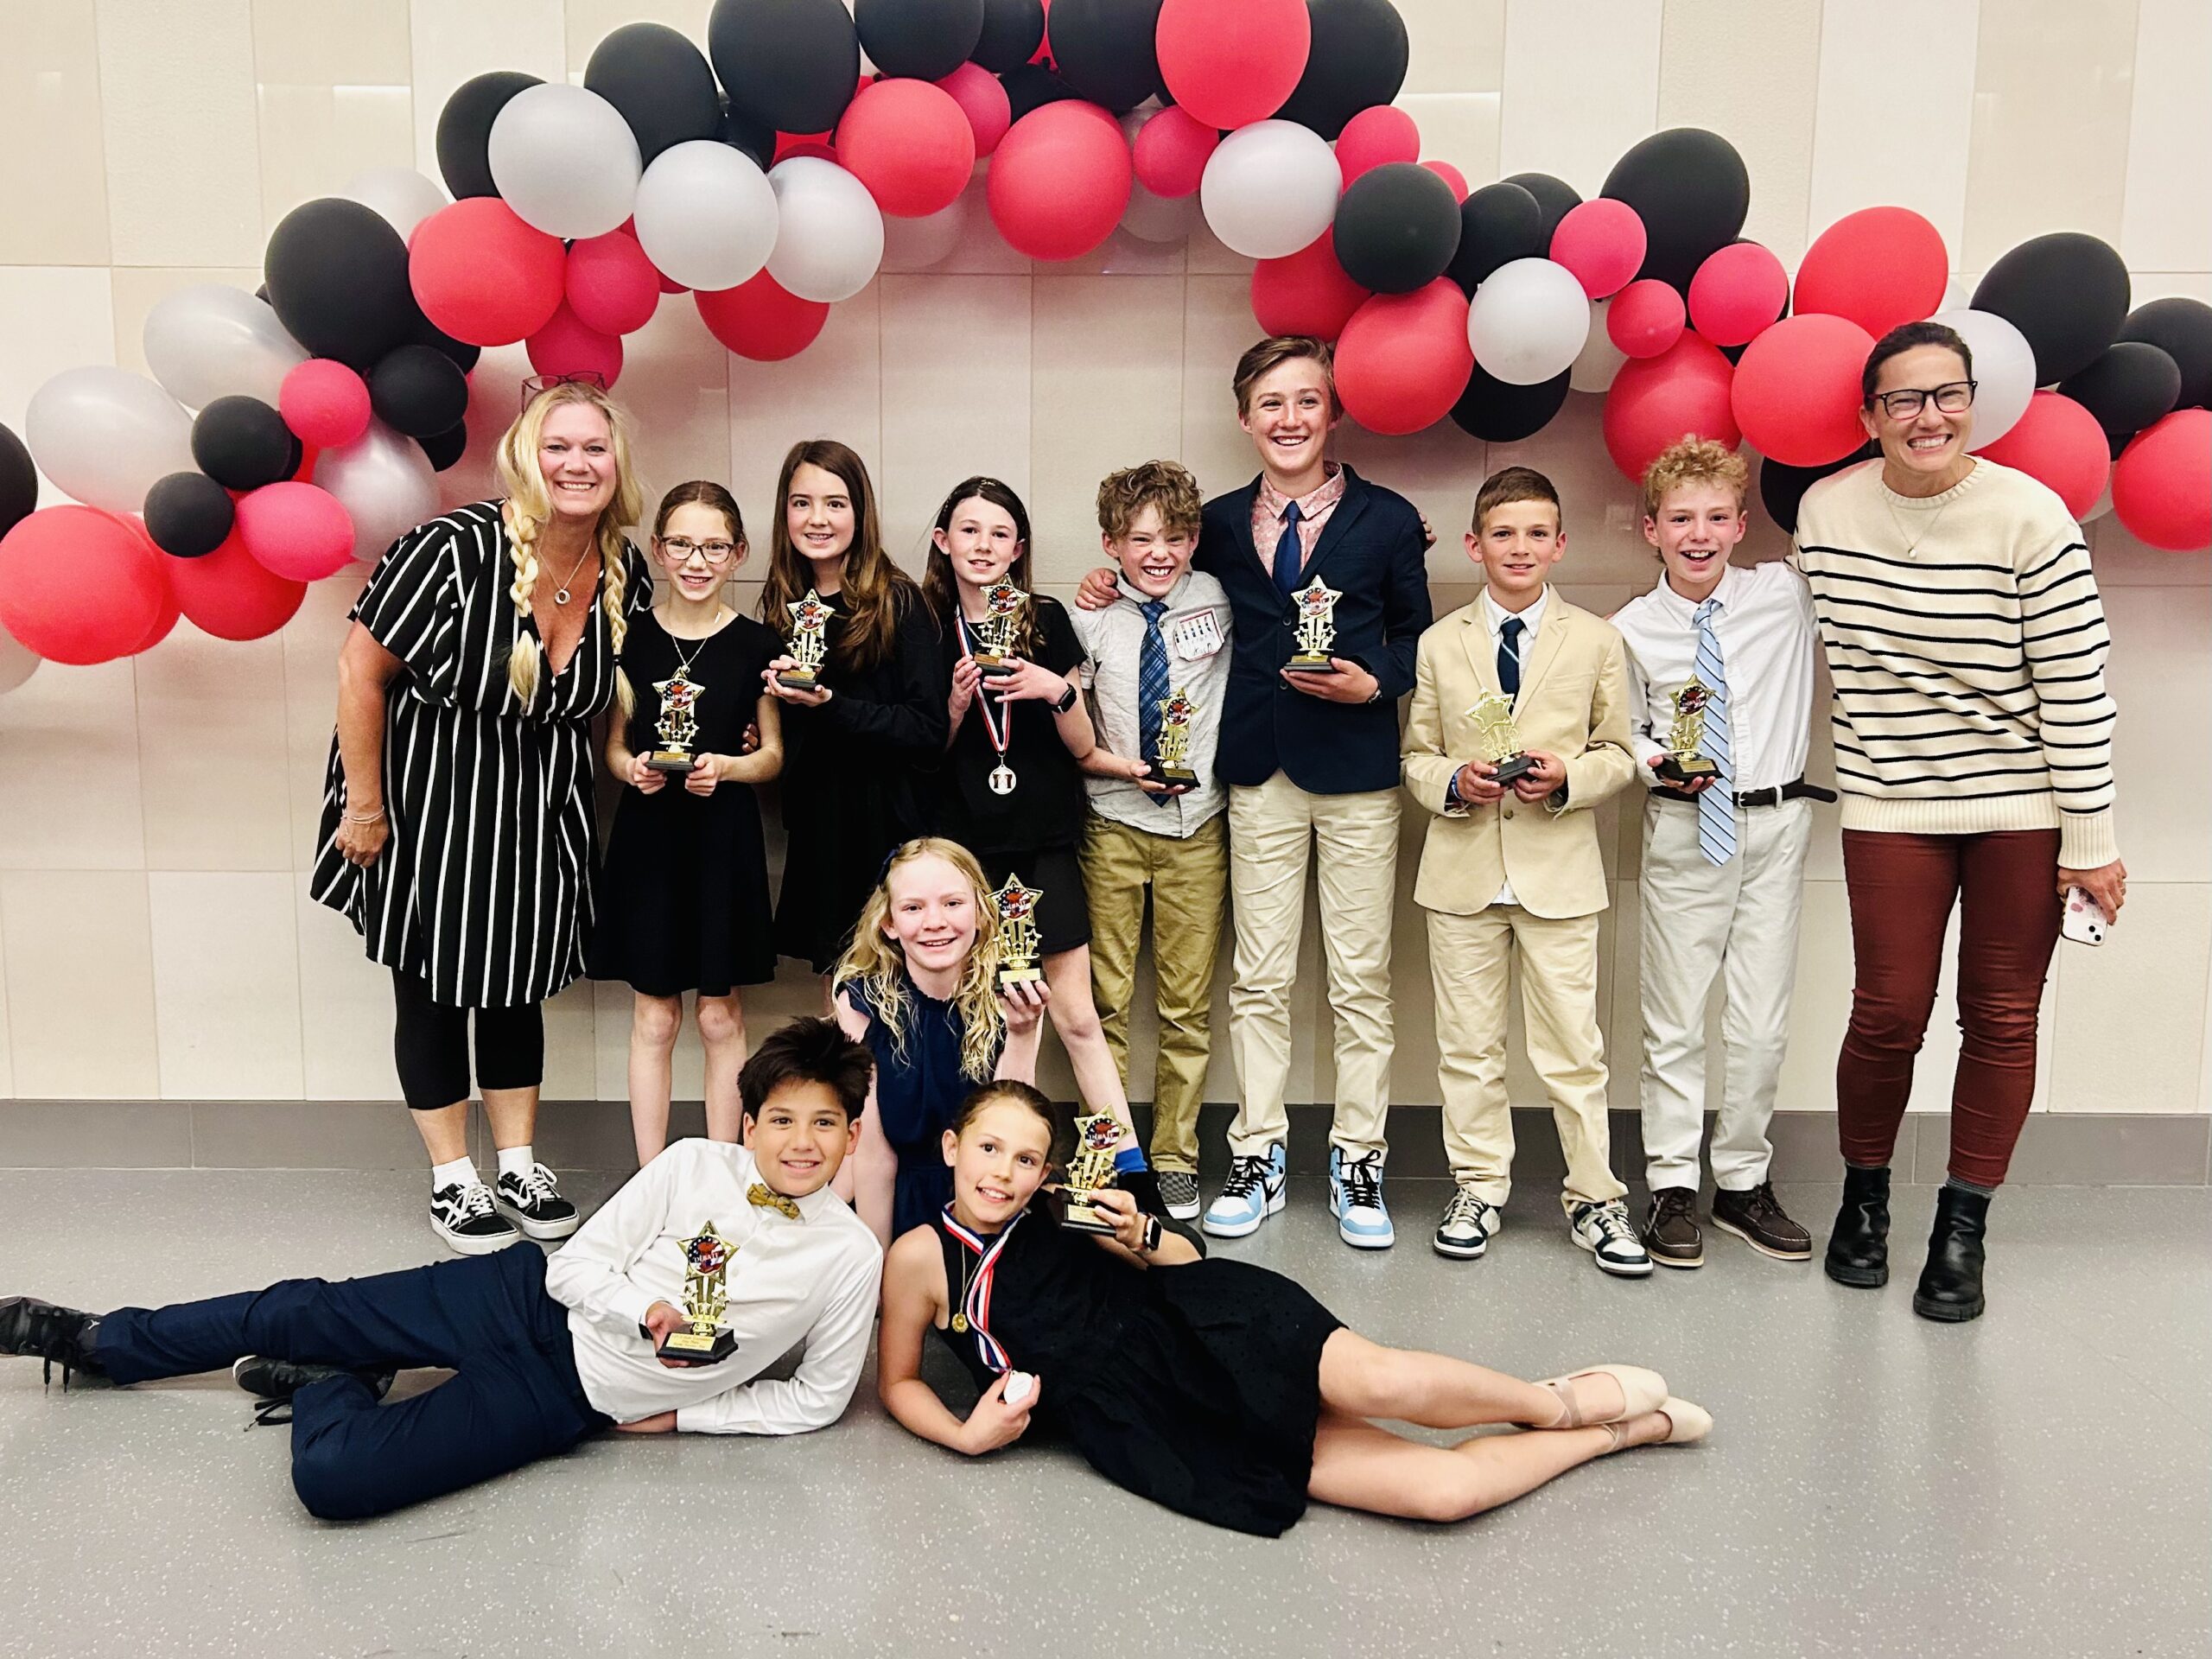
[832,836,1046,1243]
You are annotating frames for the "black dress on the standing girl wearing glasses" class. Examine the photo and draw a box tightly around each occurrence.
[591,615,783,998]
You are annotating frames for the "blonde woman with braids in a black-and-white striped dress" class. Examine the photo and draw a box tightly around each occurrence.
[312,380,652,1255]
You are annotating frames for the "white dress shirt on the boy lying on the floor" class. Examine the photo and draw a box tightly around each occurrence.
[546,1139,882,1433]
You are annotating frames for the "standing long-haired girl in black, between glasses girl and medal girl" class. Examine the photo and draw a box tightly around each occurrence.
[761,438,944,973]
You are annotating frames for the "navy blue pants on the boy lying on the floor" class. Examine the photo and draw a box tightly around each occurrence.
[95,1243,608,1520]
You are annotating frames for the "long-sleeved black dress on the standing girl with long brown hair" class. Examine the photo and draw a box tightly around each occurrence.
[777,586,949,973]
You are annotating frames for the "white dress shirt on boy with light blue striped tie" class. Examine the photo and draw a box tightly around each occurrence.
[1612,560,1818,790]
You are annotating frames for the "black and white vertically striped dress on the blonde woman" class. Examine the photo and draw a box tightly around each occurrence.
[309,500,652,1008]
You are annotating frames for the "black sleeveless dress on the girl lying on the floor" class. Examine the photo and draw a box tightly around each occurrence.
[931,1210,1343,1537]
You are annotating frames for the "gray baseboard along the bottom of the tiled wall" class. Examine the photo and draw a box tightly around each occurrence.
[0,1099,2212,1185]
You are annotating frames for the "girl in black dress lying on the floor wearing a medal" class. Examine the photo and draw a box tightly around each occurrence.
[876,1084,1712,1537]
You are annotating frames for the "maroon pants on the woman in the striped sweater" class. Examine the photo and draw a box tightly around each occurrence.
[1836,830,2059,1185]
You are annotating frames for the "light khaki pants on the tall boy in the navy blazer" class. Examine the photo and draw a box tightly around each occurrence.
[1228,772,1398,1157]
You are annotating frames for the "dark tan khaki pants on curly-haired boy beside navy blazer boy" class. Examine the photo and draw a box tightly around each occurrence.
[1082,812,1228,1174]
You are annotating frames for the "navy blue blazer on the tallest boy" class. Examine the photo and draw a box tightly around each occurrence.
[1192,467,1431,794]
